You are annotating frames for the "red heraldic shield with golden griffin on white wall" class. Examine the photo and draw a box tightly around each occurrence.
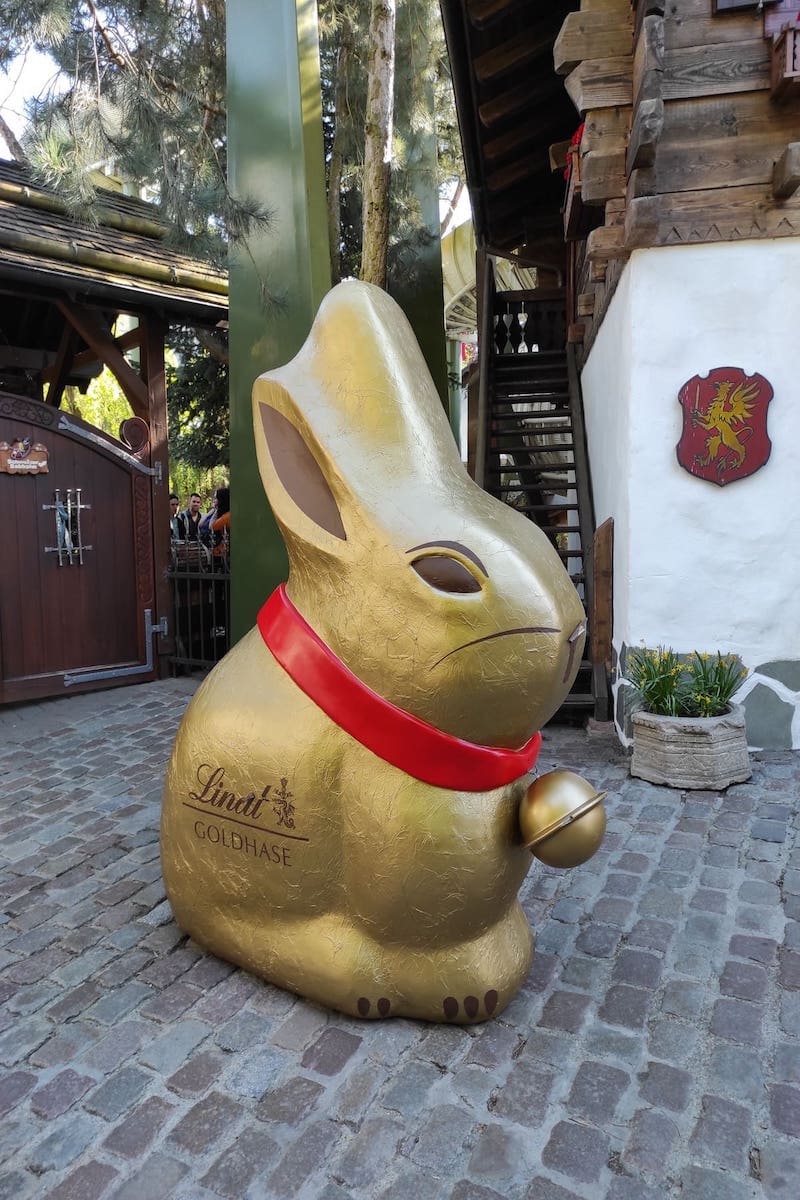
[675,367,774,487]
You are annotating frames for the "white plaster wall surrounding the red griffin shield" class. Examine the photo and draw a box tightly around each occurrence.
[582,238,800,736]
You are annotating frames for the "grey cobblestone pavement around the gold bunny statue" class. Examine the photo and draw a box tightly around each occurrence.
[0,680,800,1200]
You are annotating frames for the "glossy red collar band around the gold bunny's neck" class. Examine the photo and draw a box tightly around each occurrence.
[258,583,542,792]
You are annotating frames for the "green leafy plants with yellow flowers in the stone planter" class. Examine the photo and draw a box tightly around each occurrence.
[626,646,747,716]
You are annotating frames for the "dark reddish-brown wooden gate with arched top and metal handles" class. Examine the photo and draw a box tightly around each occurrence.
[0,394,160,703]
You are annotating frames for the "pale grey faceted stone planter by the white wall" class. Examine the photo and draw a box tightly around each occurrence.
[631,704,752,792]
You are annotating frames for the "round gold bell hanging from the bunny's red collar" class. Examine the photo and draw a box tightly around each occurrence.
[519,770,606,866]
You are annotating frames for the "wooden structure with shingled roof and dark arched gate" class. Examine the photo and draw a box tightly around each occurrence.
[0,162,227,703]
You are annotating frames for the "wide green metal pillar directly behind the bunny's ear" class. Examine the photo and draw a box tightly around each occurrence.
[227,0,331,641]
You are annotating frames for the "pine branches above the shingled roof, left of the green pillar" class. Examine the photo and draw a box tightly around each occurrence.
[0,0,269,265]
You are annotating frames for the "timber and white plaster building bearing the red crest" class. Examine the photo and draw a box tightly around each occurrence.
[441,0,800,748]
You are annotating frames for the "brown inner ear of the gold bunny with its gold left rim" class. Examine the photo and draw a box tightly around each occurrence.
[255,389,347,544]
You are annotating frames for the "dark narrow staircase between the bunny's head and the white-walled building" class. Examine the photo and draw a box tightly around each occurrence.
[475,264,608,719]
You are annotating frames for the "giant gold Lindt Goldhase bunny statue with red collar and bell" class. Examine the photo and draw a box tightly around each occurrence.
[162,282,604,1022]
